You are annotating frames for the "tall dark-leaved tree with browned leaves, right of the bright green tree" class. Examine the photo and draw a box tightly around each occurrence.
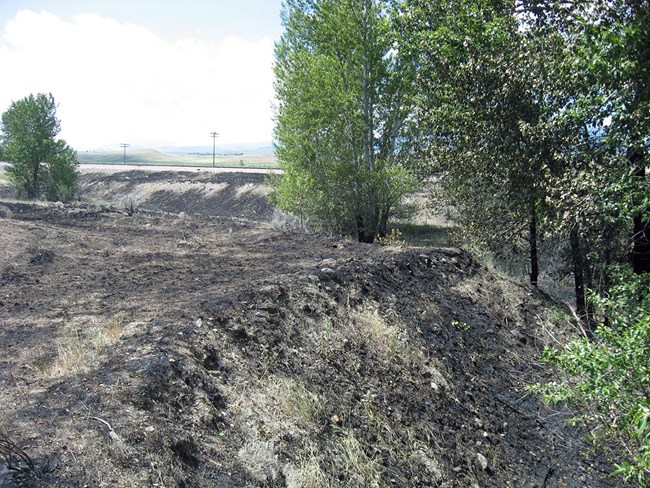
[401,0,565,285]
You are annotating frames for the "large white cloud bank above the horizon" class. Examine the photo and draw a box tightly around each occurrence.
[0,10,273,150]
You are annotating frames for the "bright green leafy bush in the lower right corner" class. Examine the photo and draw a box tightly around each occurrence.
[533,272,650,485]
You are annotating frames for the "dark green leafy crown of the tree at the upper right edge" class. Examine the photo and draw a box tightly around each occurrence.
[546,0,650,278]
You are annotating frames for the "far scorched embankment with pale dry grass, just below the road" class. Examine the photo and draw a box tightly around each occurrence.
[79,171,273,222]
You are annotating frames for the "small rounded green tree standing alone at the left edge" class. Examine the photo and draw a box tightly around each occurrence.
[1,94,78,201]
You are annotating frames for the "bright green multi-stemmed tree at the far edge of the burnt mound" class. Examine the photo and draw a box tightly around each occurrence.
[272,0,415,243]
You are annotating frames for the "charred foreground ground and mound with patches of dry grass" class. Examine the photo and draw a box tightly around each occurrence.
[0,196,624,487]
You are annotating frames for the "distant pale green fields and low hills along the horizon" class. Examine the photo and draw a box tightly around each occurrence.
[77,149,277,168]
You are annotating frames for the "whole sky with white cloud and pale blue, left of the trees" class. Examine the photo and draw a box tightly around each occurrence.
[0,0,282,151]
